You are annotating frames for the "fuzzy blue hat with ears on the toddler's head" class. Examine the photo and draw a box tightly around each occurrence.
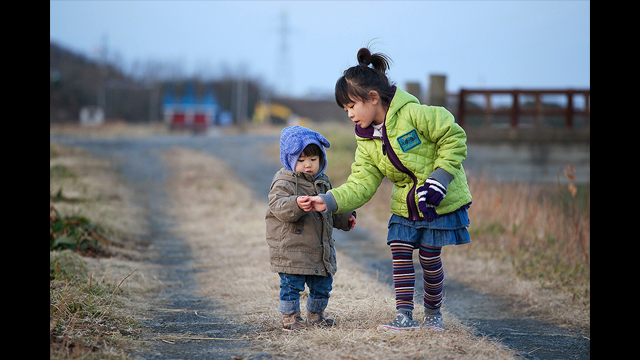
[280,126,331,178]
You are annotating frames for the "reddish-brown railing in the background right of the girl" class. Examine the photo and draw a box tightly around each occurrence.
[456,89,591,129]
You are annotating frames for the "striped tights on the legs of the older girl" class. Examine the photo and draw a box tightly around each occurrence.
[389,240,444,310]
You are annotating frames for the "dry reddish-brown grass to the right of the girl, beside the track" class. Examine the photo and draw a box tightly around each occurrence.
[456,177,591,332]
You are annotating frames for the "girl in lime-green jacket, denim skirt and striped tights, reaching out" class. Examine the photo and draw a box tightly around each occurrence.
[310,48,471,330]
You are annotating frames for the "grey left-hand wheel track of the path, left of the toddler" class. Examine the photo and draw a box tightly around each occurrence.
[49,138,261,359]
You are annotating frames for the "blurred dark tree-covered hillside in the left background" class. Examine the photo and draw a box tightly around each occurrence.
[49,42,261,122]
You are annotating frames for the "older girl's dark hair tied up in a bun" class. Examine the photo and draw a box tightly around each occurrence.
[336,47,393,109]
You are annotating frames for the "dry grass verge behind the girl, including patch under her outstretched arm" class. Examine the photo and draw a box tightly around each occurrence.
[344,178,591,333]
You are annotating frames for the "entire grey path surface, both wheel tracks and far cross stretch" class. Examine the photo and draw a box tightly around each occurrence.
[51,135,590,359]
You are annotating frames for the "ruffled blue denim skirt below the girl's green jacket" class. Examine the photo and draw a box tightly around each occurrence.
[387,208,471,247]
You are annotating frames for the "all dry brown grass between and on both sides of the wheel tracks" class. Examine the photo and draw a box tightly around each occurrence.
[50,122,590,359]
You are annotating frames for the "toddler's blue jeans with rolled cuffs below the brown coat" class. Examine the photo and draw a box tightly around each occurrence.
[278,273,333,315]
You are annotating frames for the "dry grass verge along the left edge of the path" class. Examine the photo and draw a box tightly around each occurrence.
[49,145,164,359]
